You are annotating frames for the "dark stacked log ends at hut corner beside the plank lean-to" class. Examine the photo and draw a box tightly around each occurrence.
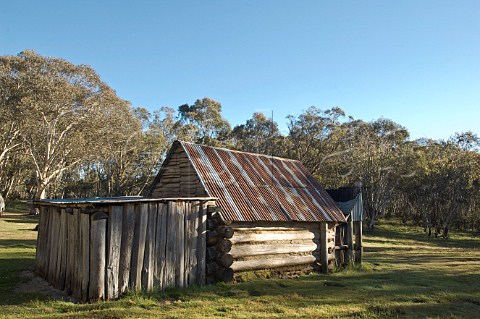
[206,206,233,283]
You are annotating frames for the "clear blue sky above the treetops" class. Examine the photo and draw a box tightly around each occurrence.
[0,0,480,139]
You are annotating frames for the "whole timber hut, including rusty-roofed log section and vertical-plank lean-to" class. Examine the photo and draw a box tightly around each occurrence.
[34,141,361,301]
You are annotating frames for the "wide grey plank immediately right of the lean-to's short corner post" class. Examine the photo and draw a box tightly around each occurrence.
[106,205,123,299]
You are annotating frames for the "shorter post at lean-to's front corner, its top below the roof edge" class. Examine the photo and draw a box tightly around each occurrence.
[88,212,108,301]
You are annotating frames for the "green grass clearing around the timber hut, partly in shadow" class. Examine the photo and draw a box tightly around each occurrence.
[0,206,480,319]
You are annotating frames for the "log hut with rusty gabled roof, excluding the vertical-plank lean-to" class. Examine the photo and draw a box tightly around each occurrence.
[149,141,346,281]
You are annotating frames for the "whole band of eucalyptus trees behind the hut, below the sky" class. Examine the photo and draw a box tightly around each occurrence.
[0,51,480,237]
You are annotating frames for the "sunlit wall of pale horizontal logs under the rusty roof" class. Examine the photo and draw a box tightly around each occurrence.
[228,222,335,273]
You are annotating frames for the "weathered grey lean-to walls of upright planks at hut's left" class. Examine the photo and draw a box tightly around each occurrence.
[36,201,207,301]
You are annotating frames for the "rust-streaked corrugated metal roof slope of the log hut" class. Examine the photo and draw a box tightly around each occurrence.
[176,142,345,222]
